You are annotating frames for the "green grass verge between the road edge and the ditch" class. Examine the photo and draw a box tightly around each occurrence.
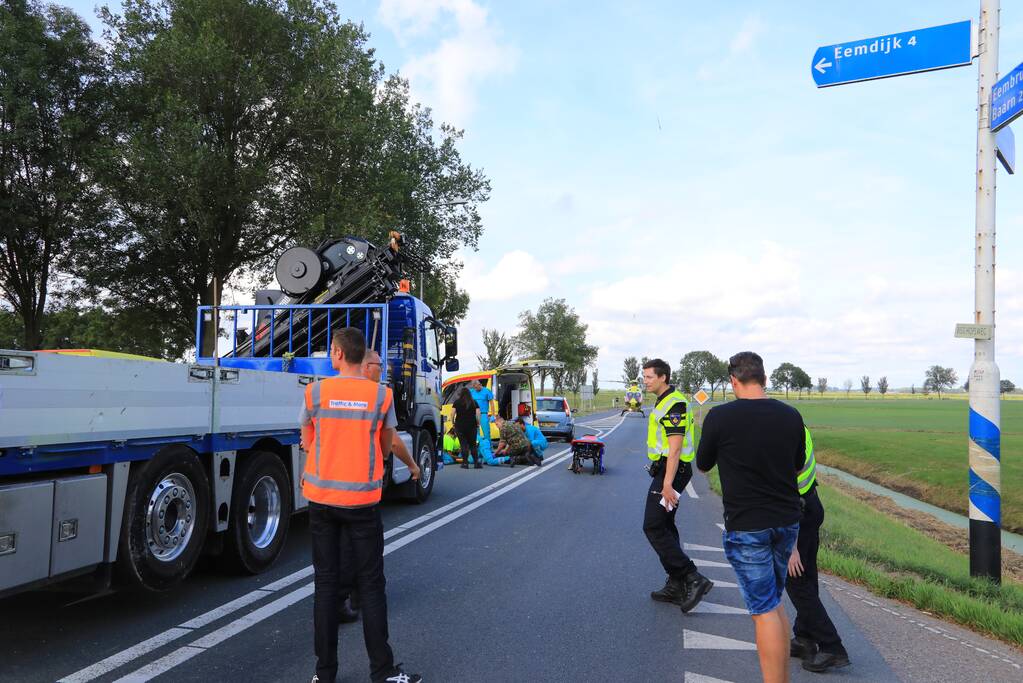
[707,468,1023,647]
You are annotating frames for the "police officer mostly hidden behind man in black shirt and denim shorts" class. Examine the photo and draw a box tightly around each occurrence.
[785,429,849,674]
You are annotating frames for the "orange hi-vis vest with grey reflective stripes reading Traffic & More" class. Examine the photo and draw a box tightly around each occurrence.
[302,377,394,507]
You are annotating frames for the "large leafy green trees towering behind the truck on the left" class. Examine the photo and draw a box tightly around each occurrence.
[0,0,490,358]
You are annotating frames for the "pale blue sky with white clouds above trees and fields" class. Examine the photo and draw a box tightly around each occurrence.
[61,0,1023,388]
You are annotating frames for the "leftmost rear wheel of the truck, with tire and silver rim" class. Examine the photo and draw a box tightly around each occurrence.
[117,446,210,591]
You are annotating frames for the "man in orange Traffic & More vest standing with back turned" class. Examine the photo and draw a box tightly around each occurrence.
[300,327,422,683]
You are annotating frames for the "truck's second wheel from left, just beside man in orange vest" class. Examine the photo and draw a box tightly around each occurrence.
[227,451,292,574]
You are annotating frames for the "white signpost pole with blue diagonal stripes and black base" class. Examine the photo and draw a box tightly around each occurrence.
[970,0,1002,583]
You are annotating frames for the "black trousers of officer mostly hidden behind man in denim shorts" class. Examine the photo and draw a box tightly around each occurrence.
[785,489,845,654]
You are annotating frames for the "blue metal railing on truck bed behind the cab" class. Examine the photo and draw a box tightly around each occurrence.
[195,304,388,382]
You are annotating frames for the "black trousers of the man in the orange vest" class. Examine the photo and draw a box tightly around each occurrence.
[309,502,394,683]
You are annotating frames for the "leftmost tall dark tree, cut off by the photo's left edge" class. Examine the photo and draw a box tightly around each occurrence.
[0,0,105,350]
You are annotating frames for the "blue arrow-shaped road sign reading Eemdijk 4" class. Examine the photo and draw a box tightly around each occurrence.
[810,21,973,88]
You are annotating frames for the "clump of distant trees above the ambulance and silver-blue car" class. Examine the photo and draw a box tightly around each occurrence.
[476,298,601,396]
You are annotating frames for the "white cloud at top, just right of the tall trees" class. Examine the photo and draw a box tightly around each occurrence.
[380,0,518,126]
